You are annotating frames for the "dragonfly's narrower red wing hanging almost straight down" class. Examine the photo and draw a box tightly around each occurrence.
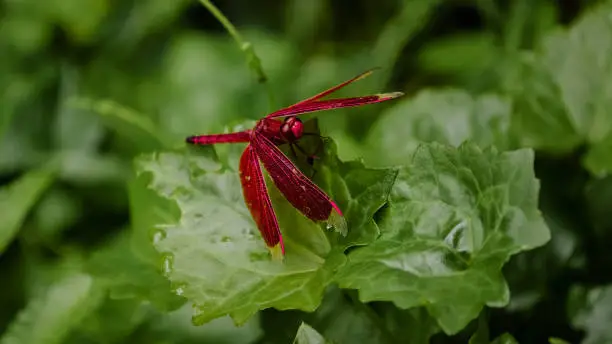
[240,145,285,260]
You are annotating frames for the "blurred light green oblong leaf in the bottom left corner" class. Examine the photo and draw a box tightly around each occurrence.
[0,274,103,344]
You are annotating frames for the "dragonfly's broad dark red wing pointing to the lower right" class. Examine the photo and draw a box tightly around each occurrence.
[251,133,347,235]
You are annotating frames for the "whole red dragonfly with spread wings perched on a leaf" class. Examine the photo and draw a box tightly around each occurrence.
[186,70,403,260]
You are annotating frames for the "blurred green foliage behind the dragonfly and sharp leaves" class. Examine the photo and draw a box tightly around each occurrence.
[0,0,612,344]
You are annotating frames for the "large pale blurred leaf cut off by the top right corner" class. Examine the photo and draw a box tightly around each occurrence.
[541,3,612,142]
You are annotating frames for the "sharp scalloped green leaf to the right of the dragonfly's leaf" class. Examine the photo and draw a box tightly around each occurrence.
[337,144,550,334]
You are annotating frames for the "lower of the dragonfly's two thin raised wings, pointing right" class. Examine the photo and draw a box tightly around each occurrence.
[266,92,404,118]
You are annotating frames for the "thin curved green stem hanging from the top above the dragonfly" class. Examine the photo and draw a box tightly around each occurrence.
[200,0,274,109]
